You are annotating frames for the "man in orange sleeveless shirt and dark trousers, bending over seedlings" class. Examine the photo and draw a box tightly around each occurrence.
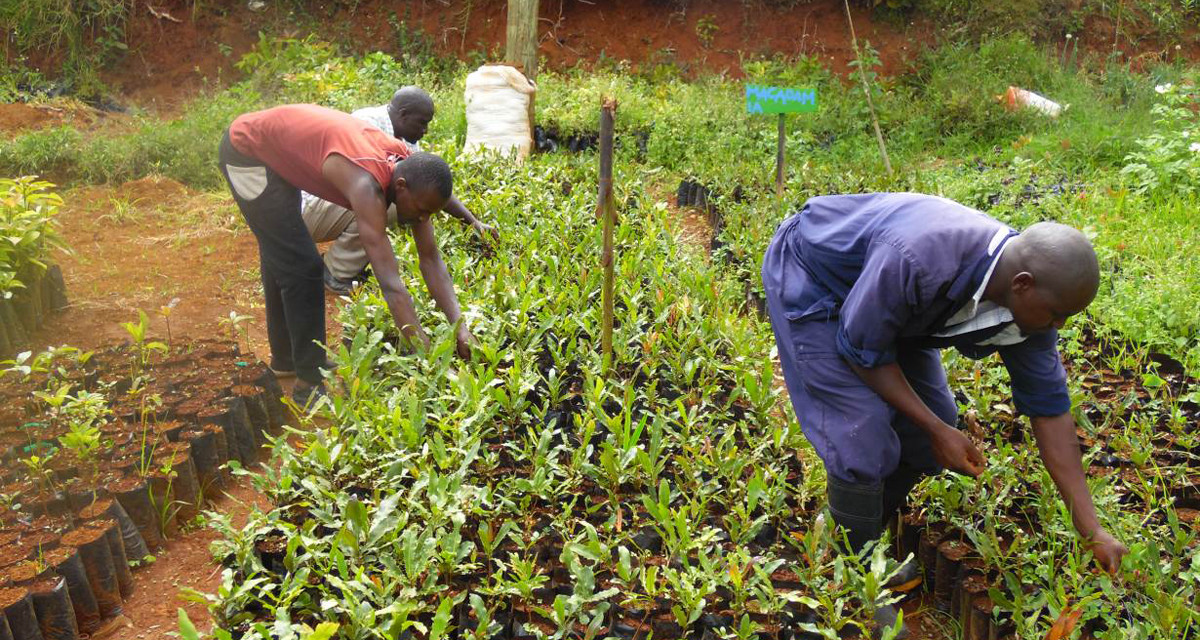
[218,104,474,405]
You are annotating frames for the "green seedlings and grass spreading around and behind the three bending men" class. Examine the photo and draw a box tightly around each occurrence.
[0,13,1200,639]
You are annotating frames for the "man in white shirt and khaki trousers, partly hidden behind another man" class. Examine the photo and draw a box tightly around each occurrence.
[300,86,497,294]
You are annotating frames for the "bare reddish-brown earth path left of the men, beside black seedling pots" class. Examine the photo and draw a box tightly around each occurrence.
[24,172,335,640]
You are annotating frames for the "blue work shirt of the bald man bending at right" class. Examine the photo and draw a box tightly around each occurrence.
[763,193,1070,417]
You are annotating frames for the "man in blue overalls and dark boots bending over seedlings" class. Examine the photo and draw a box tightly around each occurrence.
[762,193,1127,627]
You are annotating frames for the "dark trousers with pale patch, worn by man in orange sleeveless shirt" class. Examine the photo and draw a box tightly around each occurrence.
[217,131,325,384]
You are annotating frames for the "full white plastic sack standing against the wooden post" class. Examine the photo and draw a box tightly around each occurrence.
[463,65,538,160]
